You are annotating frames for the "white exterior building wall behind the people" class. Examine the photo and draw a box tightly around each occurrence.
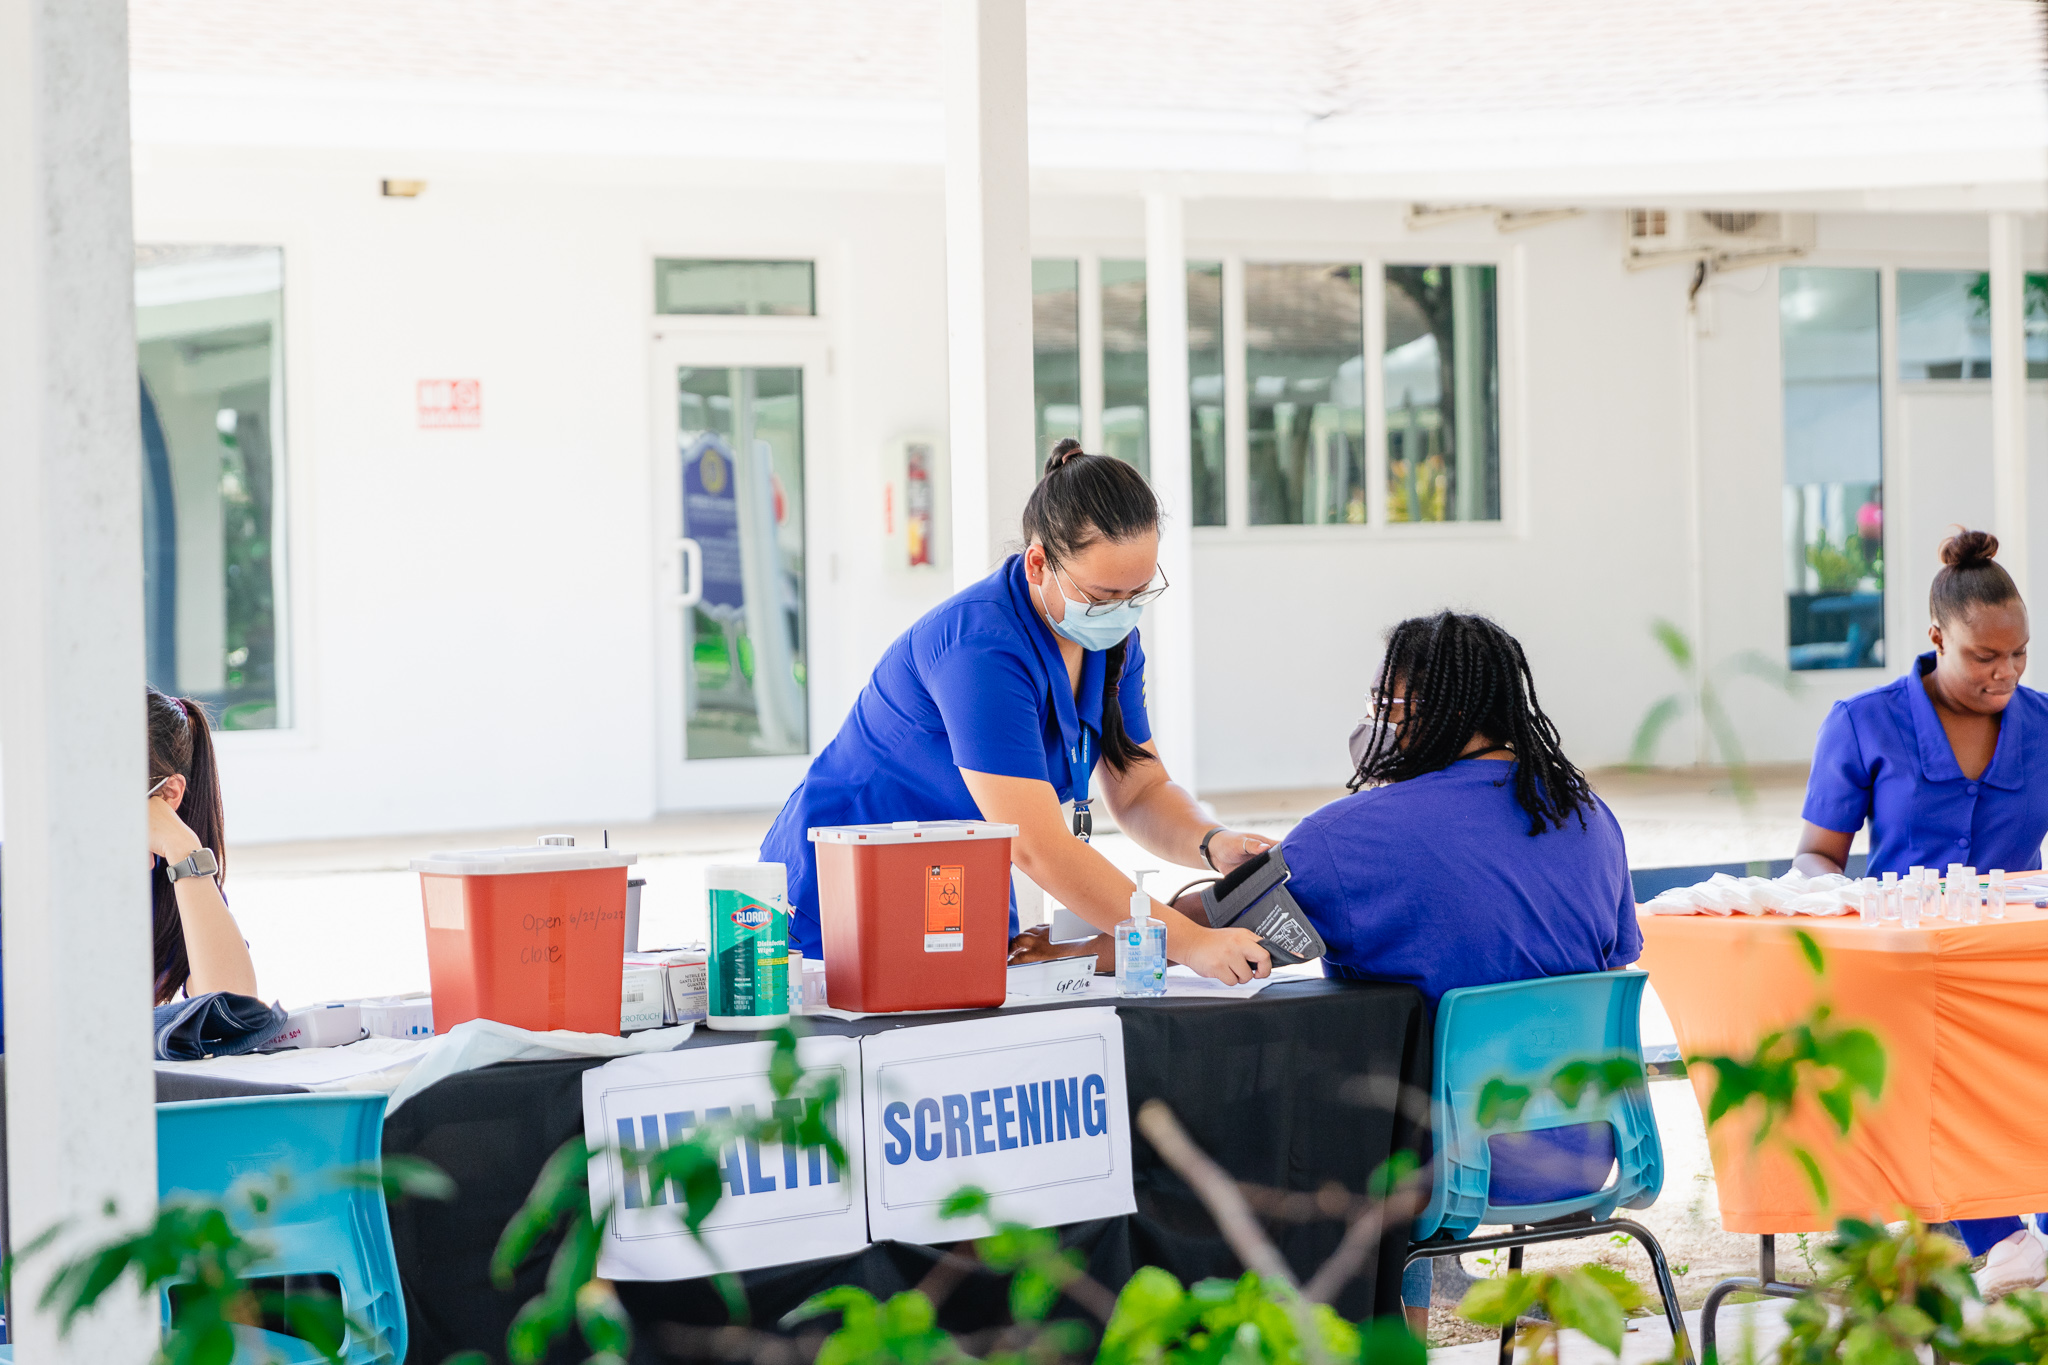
[137,149,2048,839]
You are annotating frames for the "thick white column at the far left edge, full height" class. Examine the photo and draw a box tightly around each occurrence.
[0,0,158,1365]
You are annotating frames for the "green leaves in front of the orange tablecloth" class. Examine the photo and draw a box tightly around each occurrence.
[1686,929,1884,1207]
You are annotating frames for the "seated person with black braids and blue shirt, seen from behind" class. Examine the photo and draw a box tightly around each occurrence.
[1280,612,1642,1330]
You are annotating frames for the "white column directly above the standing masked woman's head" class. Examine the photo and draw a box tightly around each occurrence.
[944,0,1036,587]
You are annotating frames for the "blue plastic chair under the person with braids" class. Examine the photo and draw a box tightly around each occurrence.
[1407,970,1692,1365]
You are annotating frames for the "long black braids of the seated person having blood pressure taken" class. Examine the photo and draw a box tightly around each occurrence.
[1350,612,1593,835]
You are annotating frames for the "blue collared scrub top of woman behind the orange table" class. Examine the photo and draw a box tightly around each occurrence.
[1802,653,2048,876]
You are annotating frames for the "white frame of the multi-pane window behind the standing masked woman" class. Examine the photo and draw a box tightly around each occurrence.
[1030,235,1528,544]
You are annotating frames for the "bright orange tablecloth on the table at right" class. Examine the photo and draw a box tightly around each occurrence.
[1638,905,2048,1232]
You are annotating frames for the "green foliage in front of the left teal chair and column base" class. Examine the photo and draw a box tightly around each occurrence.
[16,1156,455,1365]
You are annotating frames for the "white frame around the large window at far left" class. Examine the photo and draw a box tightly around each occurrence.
[135,224,319,757]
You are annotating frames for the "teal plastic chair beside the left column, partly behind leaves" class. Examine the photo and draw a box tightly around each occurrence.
[156,1095,406,1365]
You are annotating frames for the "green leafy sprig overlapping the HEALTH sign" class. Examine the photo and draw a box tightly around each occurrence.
[492,1029,846,1365]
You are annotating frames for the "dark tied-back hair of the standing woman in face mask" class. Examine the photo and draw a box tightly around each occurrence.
[1024,436,1159,774]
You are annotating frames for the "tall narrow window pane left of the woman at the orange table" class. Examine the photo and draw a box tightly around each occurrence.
[1778,266,1903,669]
